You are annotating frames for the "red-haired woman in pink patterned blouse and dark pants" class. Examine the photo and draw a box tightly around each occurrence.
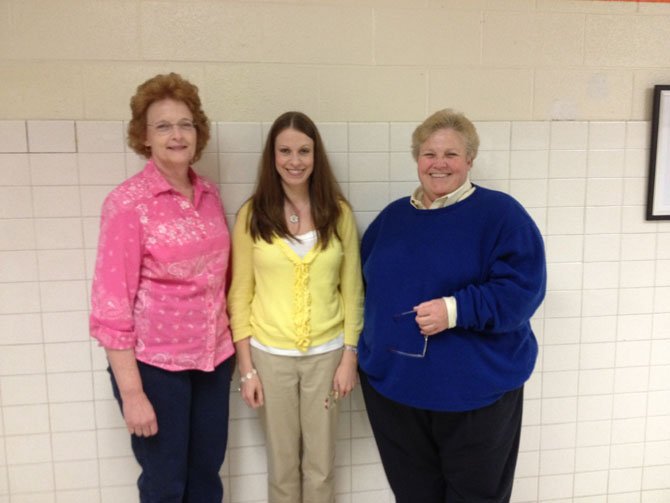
[90,73,234,503]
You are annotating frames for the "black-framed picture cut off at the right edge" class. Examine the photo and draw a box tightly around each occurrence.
[647,85,670,220]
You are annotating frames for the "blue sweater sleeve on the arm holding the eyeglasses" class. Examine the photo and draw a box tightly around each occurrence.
[454,216,547,333]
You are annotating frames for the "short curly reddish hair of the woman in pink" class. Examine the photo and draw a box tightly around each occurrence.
[128,73,210,162]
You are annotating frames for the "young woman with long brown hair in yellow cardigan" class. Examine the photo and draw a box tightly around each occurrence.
[228,112,363,503]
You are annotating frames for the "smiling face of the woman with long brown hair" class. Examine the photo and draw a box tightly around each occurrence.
[275,128,314,188]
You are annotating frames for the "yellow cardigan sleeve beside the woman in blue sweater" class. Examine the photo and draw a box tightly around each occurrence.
[338,204,363,346]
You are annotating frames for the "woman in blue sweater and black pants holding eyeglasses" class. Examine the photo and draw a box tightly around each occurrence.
[359,109,546,503]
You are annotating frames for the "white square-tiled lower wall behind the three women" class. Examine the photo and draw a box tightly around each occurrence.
[0,120,670,503]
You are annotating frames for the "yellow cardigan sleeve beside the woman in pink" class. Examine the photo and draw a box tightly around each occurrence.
[228,202,256,342]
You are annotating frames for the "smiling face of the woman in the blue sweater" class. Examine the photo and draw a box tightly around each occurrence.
[417,129,472,206]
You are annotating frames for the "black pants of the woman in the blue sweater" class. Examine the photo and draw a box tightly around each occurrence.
[360,372,523,503]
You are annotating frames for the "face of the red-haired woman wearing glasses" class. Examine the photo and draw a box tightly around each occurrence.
[144,98,198,171]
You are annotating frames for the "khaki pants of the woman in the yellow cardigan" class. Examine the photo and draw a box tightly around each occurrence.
[251,346,342,503]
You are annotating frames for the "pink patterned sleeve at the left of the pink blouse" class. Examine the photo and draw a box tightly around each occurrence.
[89,195,142,350]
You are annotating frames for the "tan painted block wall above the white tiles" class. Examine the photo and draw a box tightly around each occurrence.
[0,0,670,121]
